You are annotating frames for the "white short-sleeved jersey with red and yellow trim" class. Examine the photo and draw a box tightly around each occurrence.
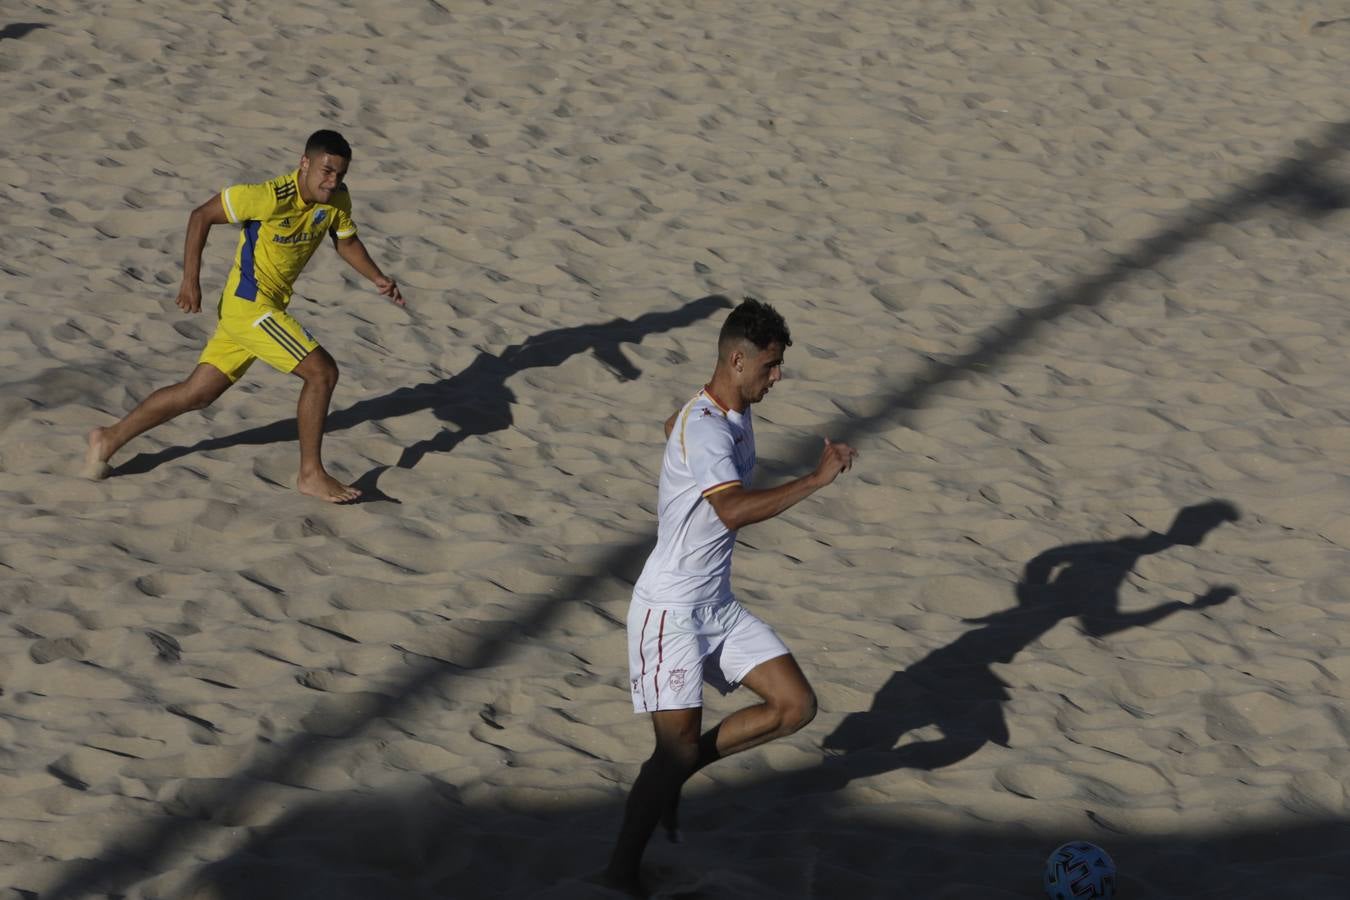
[633,387,755,609]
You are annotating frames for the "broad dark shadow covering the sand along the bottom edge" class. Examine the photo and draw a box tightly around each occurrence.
[182,739,1350,900]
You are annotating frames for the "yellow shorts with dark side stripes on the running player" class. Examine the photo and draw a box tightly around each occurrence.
[197,297,319,382]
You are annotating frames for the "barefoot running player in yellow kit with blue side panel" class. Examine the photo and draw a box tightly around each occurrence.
[85,130,404,503]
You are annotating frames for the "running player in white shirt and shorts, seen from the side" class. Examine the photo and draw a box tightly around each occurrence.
[605,300,857,895]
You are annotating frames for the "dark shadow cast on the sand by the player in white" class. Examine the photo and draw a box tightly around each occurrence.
[825,501,1239,780]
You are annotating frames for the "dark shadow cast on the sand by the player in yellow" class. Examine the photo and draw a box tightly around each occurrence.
[112,294,732,499]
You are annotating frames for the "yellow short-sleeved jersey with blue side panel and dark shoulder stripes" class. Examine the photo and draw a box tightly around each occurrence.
[220,169,356,309]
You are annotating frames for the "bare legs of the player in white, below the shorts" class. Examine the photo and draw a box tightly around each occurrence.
[606,654,815,893]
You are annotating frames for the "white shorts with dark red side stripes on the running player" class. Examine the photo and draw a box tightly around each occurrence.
[628,598,788,712]
